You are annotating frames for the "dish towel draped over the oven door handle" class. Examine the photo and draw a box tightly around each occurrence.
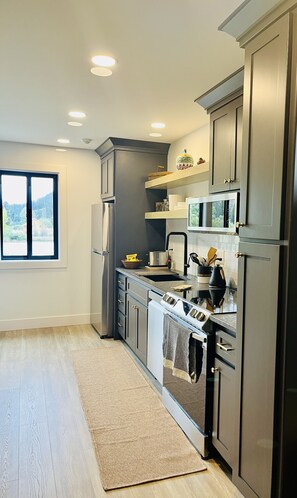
[163,315,203,384]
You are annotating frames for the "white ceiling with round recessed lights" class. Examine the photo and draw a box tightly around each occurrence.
[0,0,243,149]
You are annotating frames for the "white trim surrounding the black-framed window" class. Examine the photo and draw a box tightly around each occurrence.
[0,161,68,270]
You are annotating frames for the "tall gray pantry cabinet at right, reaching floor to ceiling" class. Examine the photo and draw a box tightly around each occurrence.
[222,0,297,498]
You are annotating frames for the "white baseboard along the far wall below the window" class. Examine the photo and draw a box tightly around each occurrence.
[0,314,90,332]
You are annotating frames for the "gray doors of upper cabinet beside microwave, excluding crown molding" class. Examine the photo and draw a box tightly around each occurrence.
[209,96,243,192]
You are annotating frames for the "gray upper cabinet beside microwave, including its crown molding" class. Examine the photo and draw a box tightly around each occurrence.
[196,68,243,192]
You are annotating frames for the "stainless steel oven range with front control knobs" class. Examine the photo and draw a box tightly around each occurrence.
[162,293,214,457]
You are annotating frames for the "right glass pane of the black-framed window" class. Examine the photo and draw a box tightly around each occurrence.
[31,178,54,256]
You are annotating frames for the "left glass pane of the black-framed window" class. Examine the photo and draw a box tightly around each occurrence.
[2,175,27,256]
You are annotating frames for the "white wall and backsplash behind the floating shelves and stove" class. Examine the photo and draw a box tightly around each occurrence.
[166,125,239,285]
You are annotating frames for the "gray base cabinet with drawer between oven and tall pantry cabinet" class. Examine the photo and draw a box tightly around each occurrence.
[212,328,236,467]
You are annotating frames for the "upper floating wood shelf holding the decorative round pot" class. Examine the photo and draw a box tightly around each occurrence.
[145,163,209,190]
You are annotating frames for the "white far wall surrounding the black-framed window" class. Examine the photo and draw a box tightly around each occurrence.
[0,142,100,331]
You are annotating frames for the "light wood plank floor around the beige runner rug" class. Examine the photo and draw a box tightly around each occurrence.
[0,326,242,498]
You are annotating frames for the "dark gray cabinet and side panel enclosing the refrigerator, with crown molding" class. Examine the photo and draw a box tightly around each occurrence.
[96,137,169,266]
